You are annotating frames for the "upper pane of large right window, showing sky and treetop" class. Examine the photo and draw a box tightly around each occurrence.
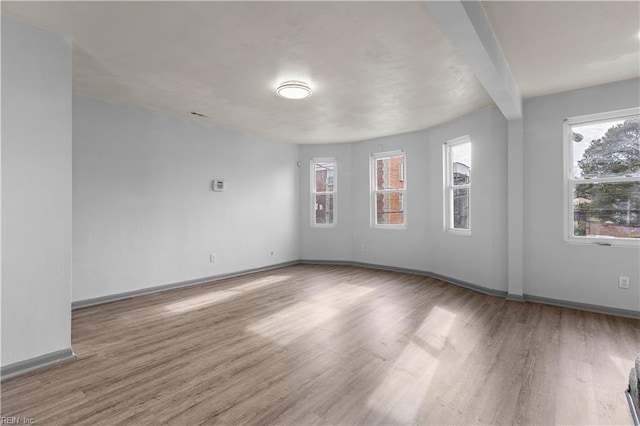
[569,116,640,179]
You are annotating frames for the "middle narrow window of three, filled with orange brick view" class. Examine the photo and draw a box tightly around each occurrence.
[371,151,407,227]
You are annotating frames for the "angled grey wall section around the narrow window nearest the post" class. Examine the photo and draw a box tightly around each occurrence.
[428,108,507,291]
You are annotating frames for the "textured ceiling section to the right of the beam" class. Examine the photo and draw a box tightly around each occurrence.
[482,1,640,98]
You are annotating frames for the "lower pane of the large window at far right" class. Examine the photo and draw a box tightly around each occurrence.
[573,182,640,238]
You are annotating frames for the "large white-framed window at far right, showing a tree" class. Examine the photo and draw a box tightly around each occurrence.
[564,108,640,245]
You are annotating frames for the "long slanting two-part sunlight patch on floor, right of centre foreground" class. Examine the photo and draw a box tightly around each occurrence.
[367,306,456,423]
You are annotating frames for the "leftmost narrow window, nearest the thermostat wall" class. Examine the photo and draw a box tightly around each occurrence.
[311,158,337,226]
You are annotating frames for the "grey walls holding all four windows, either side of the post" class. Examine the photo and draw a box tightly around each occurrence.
[300,80,640,311]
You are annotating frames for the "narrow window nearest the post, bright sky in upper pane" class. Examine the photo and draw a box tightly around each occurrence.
[444,136,471,234]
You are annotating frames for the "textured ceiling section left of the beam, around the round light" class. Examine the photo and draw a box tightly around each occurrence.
[2,2,491,143]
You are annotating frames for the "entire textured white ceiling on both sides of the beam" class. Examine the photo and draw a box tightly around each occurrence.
[0,1,640,143]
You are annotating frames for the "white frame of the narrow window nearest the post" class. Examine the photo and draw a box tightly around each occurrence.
[442,135,473,236]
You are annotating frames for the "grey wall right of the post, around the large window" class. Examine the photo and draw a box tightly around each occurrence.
[524,80,640,311]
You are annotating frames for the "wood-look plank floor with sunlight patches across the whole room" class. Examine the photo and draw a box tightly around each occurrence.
[2,265,640,425]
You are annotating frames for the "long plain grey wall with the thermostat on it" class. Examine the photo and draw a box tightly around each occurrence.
[73,96,299,301]
